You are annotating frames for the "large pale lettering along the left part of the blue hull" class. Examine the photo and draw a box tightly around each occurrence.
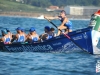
[5,45,53,51]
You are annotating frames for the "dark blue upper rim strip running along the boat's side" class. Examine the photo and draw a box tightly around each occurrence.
[0,27,92,46]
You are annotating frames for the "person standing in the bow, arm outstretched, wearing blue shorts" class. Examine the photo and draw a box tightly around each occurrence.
[45,10,72,36]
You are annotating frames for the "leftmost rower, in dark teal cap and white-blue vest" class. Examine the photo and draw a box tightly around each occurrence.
[1,30,12,44]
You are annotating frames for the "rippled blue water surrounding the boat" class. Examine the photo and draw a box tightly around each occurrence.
[0,16,100,75]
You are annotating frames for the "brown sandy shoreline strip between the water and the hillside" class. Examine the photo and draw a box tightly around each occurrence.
[0,12,91,20]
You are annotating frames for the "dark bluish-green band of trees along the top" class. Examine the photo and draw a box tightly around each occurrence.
[8,0,100,7]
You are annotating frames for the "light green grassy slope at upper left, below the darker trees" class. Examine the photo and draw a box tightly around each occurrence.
[0,0,45,12]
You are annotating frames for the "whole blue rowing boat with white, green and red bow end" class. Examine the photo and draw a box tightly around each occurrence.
[0,10,100,54]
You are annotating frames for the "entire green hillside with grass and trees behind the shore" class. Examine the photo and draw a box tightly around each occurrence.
[0,0,100,13]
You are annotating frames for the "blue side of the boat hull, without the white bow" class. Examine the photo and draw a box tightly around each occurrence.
[0,27,93,54]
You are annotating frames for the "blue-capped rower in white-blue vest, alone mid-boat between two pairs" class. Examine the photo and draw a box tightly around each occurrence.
[26,27,39,43]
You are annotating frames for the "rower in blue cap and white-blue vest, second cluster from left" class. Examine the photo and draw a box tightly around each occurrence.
[16,27,26,42]
